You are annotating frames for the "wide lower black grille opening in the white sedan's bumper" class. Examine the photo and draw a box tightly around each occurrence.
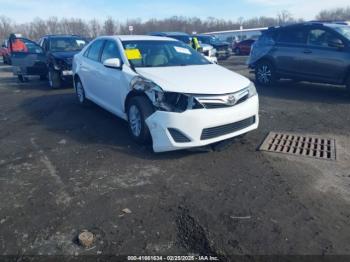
[201,116,256,140]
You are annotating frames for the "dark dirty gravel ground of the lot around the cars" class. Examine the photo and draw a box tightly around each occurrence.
[0,57,350,261]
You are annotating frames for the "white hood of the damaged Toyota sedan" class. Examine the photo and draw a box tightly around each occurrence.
[136,64,250,95]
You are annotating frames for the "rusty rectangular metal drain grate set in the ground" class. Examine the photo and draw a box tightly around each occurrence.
[260,132,336,160]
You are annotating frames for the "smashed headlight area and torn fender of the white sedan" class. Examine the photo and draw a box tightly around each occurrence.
[130,76,203,113]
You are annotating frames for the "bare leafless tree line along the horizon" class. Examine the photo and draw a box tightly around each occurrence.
[0,7,350,40]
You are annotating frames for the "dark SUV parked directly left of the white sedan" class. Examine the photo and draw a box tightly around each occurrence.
[39,35,87,88]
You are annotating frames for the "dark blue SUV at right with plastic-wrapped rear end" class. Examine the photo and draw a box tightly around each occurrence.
[248,22,350,93]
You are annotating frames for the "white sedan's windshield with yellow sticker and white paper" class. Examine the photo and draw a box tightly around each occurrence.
[123,41,210,67]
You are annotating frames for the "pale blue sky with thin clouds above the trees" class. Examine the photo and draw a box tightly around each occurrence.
[0,0,350,22]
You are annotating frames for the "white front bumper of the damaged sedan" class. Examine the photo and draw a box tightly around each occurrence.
[146,95,259,152]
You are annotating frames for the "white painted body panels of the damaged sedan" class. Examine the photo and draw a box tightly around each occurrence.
[73,36,259,152]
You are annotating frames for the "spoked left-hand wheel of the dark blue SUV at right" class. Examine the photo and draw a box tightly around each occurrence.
[255,61,277,87]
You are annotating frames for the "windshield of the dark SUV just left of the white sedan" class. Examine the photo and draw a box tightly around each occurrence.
[50,37,86,52]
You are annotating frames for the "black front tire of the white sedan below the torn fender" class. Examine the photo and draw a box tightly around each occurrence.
[127,96,154,144]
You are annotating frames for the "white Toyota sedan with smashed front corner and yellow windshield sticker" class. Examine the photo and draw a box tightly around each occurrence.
[73,36,259,152]
